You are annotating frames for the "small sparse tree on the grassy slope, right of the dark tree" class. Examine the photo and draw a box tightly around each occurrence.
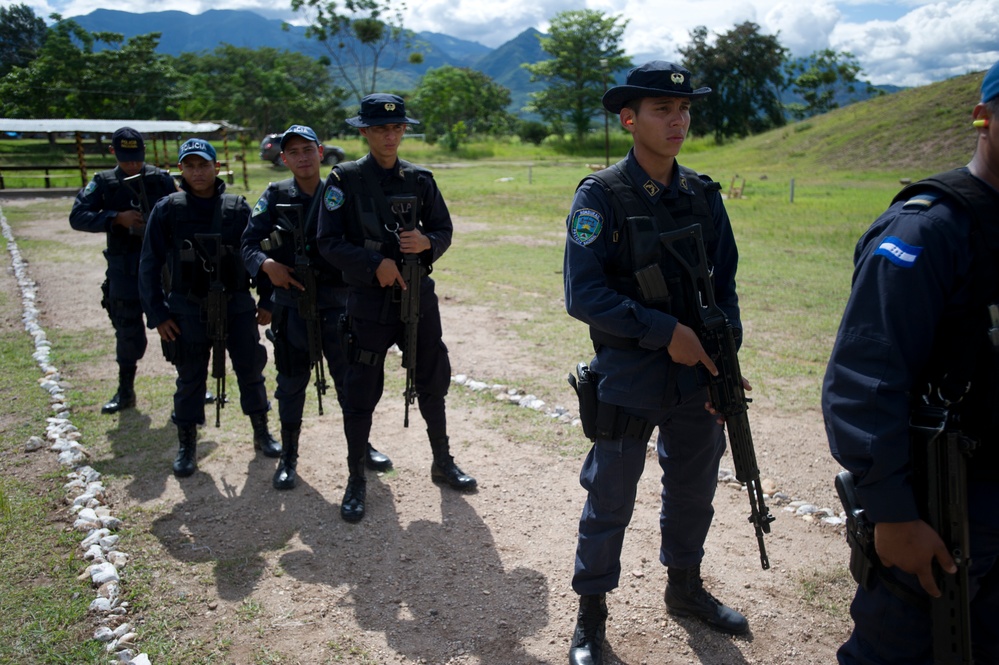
[785,49,877,120]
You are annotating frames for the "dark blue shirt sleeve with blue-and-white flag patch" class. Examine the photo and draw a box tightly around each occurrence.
[822,170,988,522]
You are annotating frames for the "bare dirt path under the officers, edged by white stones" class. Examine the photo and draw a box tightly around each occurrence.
[5,201,852,665]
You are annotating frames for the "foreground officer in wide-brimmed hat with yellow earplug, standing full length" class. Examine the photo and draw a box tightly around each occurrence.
[564,61,748,665]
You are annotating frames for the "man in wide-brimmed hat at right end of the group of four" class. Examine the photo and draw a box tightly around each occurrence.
[317,93,476,522]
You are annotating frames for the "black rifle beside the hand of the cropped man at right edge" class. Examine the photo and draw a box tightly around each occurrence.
[909,404,975,665]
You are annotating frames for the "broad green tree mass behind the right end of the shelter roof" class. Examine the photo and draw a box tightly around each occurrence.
[173,44,345,136]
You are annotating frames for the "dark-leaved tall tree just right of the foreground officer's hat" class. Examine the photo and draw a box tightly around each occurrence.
[679,21,787,141]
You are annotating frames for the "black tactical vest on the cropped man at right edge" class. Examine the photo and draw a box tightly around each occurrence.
[904,169,999,466]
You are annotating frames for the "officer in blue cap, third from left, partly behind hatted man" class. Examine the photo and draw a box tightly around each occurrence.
[242,125,392,489]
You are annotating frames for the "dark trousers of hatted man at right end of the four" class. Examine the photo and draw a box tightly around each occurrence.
[343,290,451,461]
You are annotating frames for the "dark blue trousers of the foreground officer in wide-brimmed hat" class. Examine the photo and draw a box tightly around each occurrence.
[572,388,725,595]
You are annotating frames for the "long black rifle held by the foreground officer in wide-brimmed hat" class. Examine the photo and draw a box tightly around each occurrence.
[659,224,775,570]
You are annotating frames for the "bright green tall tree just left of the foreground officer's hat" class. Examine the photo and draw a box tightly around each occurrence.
[524,9,631,140]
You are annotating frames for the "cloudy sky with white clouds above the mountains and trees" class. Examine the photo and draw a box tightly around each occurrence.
[17,0,999,86]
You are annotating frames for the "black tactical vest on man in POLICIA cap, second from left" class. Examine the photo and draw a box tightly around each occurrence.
[164,192,250,301]
